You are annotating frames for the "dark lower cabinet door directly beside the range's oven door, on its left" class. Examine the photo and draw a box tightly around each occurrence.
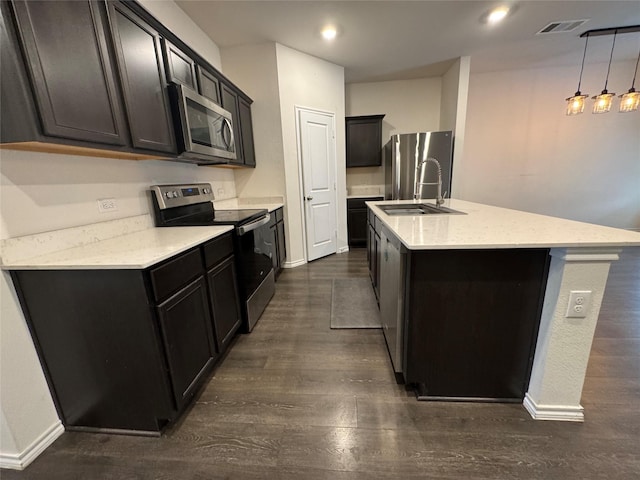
[207,255,242,353]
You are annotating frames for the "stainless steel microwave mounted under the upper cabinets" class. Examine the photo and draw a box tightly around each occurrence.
[169,85,236,163]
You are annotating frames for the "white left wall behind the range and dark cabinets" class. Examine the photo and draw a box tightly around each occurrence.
[0,0,230,464]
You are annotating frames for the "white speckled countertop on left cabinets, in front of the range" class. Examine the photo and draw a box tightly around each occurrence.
[2,225,233,270]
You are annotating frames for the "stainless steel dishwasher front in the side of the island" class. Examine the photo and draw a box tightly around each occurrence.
[380,225,406,382]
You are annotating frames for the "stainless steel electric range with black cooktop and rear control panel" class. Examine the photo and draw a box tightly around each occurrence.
[151,183,275,333]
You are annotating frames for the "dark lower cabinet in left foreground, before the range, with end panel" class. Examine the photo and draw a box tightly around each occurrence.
[11,233,240,435]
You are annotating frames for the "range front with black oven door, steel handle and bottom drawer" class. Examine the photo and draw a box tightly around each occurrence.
[236,214,275,332]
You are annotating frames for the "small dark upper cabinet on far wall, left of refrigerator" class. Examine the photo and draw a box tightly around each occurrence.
[345,115,384,167]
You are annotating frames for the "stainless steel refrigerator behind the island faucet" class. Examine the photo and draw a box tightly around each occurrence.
[383,130,453,200]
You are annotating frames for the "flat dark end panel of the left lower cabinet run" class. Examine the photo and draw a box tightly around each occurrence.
[12,270,176,434]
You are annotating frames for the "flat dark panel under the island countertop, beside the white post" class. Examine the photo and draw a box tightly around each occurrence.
[404,249,549,402]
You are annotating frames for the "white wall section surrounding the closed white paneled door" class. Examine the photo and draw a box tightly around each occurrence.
[276,44,348,265]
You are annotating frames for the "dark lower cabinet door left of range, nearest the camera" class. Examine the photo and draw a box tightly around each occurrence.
[157,277,215,408]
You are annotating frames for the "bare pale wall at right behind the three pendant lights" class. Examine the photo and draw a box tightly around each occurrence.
[454,62,640,229]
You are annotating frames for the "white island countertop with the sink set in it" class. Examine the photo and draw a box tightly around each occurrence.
[367,199,640,250]
